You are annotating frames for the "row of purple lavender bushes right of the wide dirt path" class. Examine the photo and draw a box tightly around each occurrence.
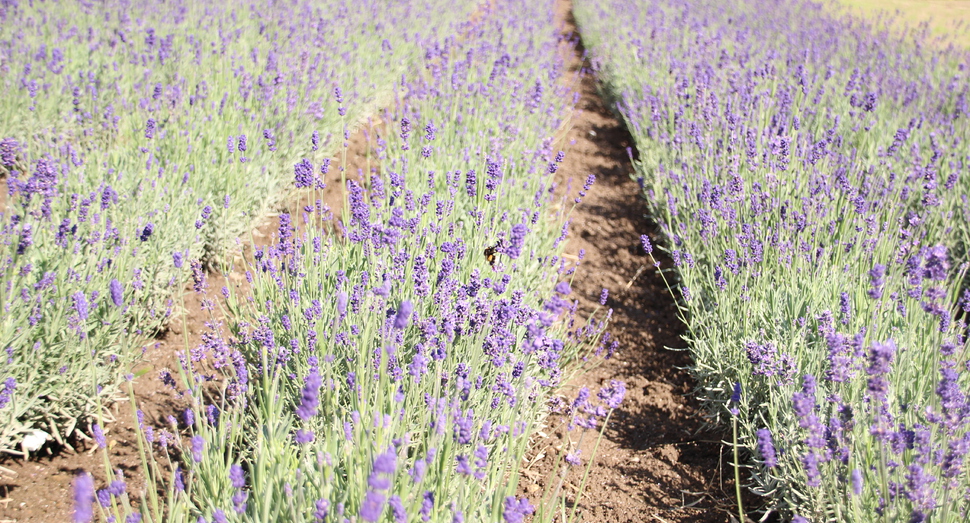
[576,0,970,521]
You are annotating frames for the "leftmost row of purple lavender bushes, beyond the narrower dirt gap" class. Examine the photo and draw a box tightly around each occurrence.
[0,0,474,455]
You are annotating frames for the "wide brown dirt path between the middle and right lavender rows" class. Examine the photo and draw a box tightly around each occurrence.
[521,0,734,523]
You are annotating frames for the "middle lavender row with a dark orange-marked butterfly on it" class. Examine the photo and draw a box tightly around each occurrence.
[76,0,624,523]
